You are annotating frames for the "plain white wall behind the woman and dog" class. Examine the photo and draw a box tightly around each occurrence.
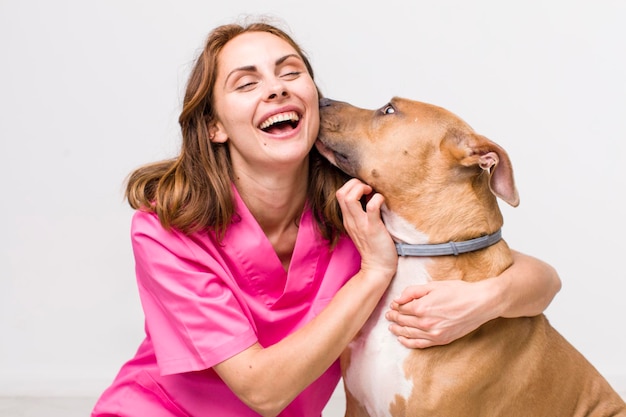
[0,0,626,396]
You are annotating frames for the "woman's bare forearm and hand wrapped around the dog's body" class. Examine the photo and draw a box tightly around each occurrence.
[387,251,561,348]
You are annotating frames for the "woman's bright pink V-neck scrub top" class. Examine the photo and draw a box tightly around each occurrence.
[92,187,360,417]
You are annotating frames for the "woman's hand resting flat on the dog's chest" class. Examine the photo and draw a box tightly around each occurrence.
[386,280,498,348]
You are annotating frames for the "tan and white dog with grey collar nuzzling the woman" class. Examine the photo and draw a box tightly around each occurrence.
[316,97,626,417]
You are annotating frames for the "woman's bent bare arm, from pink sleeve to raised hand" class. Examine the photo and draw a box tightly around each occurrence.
[214,180,397,416]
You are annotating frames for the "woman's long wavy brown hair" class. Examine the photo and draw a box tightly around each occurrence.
[125,21,348,245]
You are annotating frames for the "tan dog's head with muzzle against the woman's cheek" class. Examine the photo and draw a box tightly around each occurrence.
[316,97,519,207]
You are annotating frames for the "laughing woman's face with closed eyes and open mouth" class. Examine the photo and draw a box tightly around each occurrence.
[211,32,319,175]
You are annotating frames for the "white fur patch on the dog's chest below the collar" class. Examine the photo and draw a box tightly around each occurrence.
[344,258,429,417]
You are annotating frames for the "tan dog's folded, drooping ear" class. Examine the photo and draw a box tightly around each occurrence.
[446,132,519,207]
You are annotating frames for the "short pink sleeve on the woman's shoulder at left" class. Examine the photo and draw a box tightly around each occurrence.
[131,211,257,375]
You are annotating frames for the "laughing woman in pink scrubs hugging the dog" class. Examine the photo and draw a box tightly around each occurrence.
[92,17,560,417]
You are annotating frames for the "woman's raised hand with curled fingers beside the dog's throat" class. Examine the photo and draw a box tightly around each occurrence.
[337,178,398,281]
